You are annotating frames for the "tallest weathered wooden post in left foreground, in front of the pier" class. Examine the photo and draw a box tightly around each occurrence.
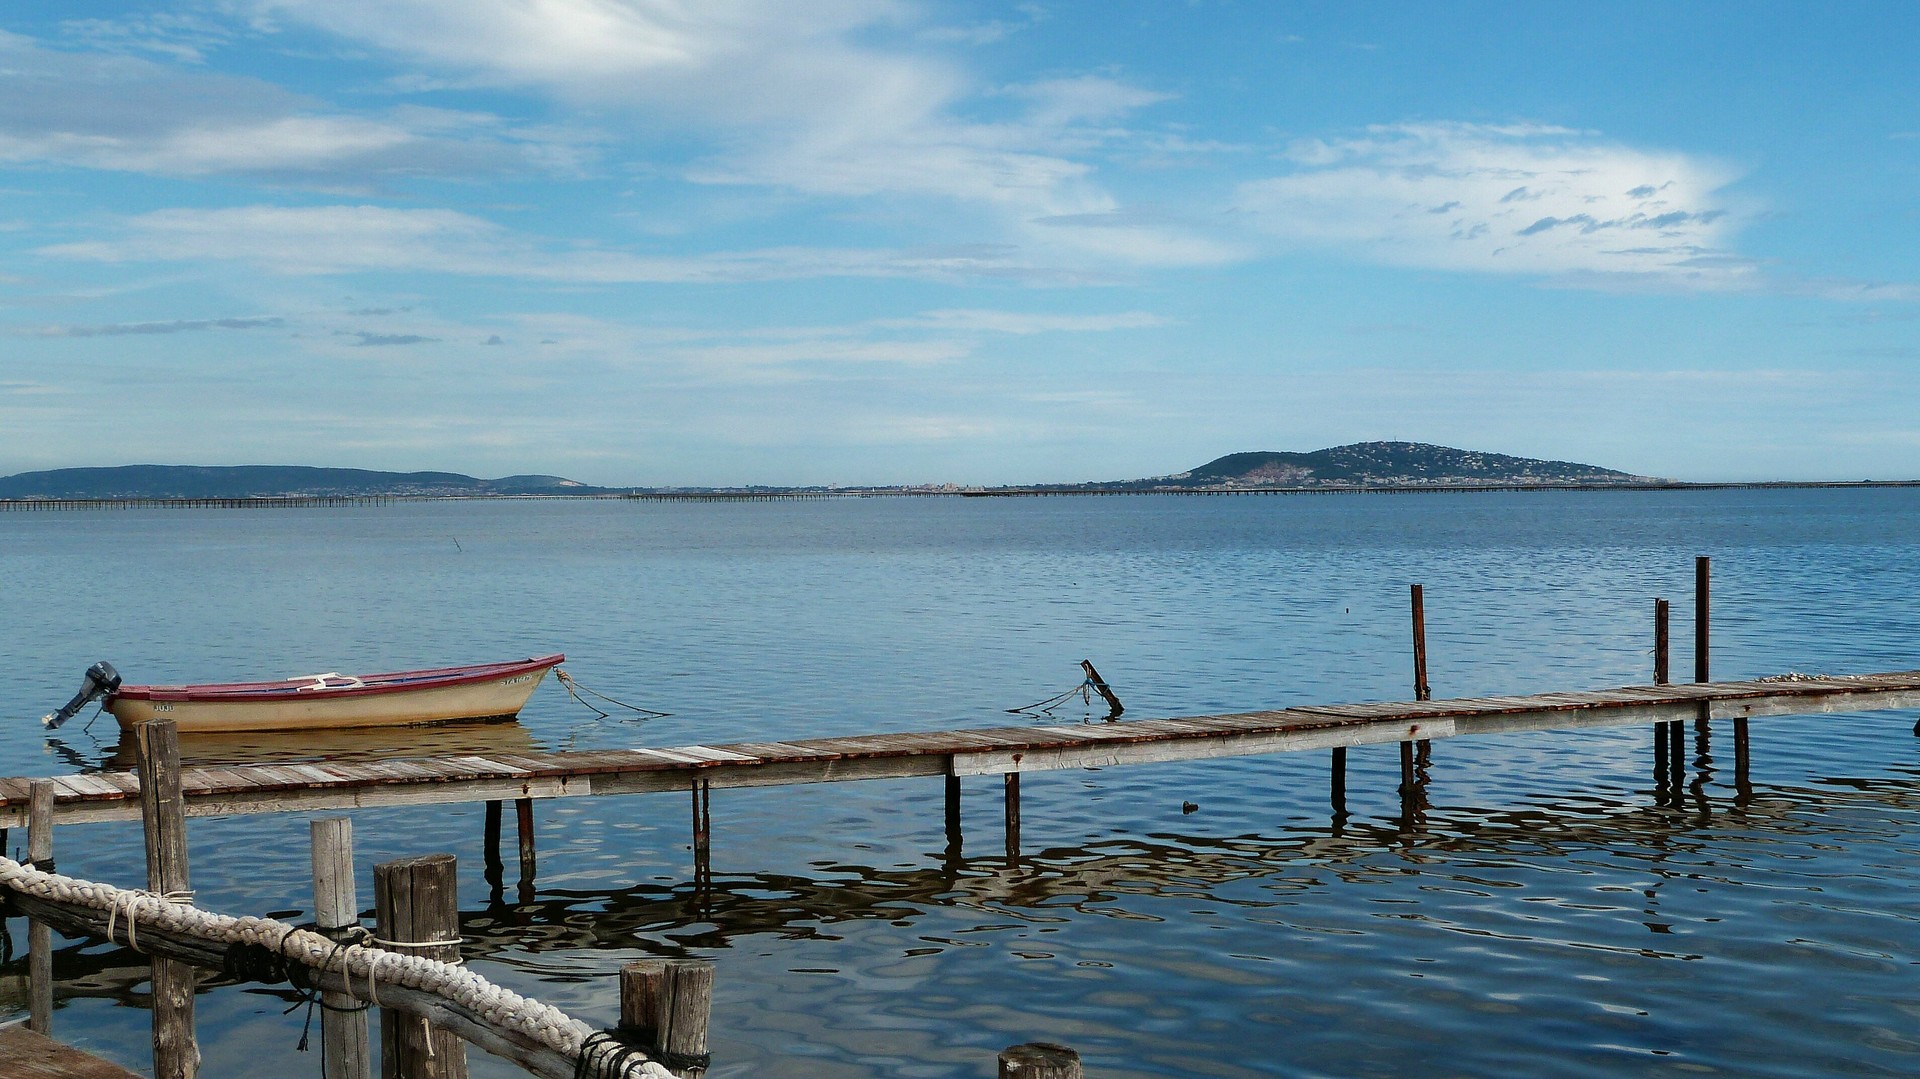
[129,720,200,1079]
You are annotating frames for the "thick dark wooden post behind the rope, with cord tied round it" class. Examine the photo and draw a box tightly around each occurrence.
[372,854,467,1079]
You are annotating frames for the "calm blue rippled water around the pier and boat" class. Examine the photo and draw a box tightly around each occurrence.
[0,490,1920,1077]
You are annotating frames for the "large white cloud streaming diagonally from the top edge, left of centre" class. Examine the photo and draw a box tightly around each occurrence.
[236,0,1221,265]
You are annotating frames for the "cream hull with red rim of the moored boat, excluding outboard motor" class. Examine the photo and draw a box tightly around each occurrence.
[108,668,547,733]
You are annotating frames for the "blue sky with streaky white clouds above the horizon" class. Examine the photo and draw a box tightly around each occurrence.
[0,0,1920,478]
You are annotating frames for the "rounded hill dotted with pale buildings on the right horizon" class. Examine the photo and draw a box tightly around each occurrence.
[1125,442,1659,488]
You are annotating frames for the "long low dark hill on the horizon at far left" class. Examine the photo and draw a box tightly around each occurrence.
[0,465,612,499]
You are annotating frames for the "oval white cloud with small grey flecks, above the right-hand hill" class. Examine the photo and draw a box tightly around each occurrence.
[1238,123,1755,288]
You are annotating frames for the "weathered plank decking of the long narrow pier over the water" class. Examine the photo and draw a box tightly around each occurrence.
[0,670,1920,827]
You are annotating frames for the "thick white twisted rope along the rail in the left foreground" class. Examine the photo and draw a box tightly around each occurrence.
[0,856,674,1079]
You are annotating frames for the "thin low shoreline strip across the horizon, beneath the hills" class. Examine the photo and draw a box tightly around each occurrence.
[0,480,1920,513]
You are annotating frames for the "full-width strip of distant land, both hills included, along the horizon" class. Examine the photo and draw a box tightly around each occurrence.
[0,442,1920,509]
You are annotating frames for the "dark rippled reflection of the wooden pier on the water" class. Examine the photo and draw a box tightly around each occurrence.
[15,766,1920,1012]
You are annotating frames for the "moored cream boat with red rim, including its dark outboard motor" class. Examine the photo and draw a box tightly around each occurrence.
[48,655,566,733]
